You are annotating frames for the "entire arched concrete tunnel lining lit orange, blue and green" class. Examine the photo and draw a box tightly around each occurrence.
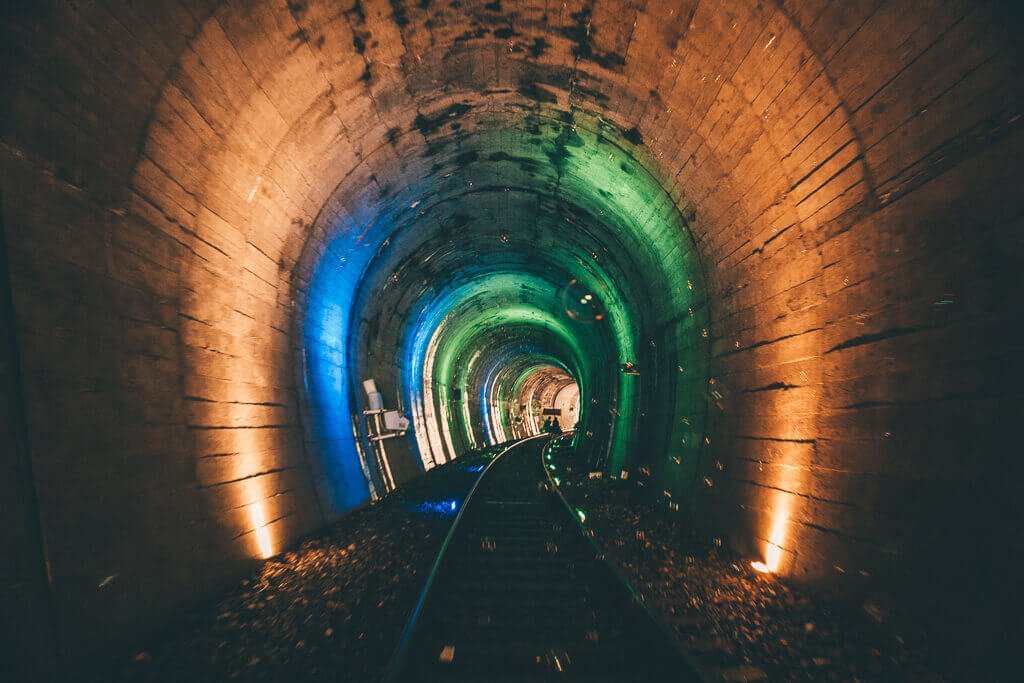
[0,0,1024,681]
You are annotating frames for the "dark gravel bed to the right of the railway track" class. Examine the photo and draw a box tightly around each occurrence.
[561,470,952,683]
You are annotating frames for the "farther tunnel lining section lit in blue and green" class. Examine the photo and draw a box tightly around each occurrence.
[298,114,710,510]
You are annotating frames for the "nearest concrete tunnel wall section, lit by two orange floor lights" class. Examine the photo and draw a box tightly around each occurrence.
[0,0,1022,660]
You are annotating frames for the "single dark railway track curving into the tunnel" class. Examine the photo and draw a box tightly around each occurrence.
[384,437,701,683]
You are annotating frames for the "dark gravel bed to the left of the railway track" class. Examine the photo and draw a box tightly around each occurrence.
[117,456,485,683]
